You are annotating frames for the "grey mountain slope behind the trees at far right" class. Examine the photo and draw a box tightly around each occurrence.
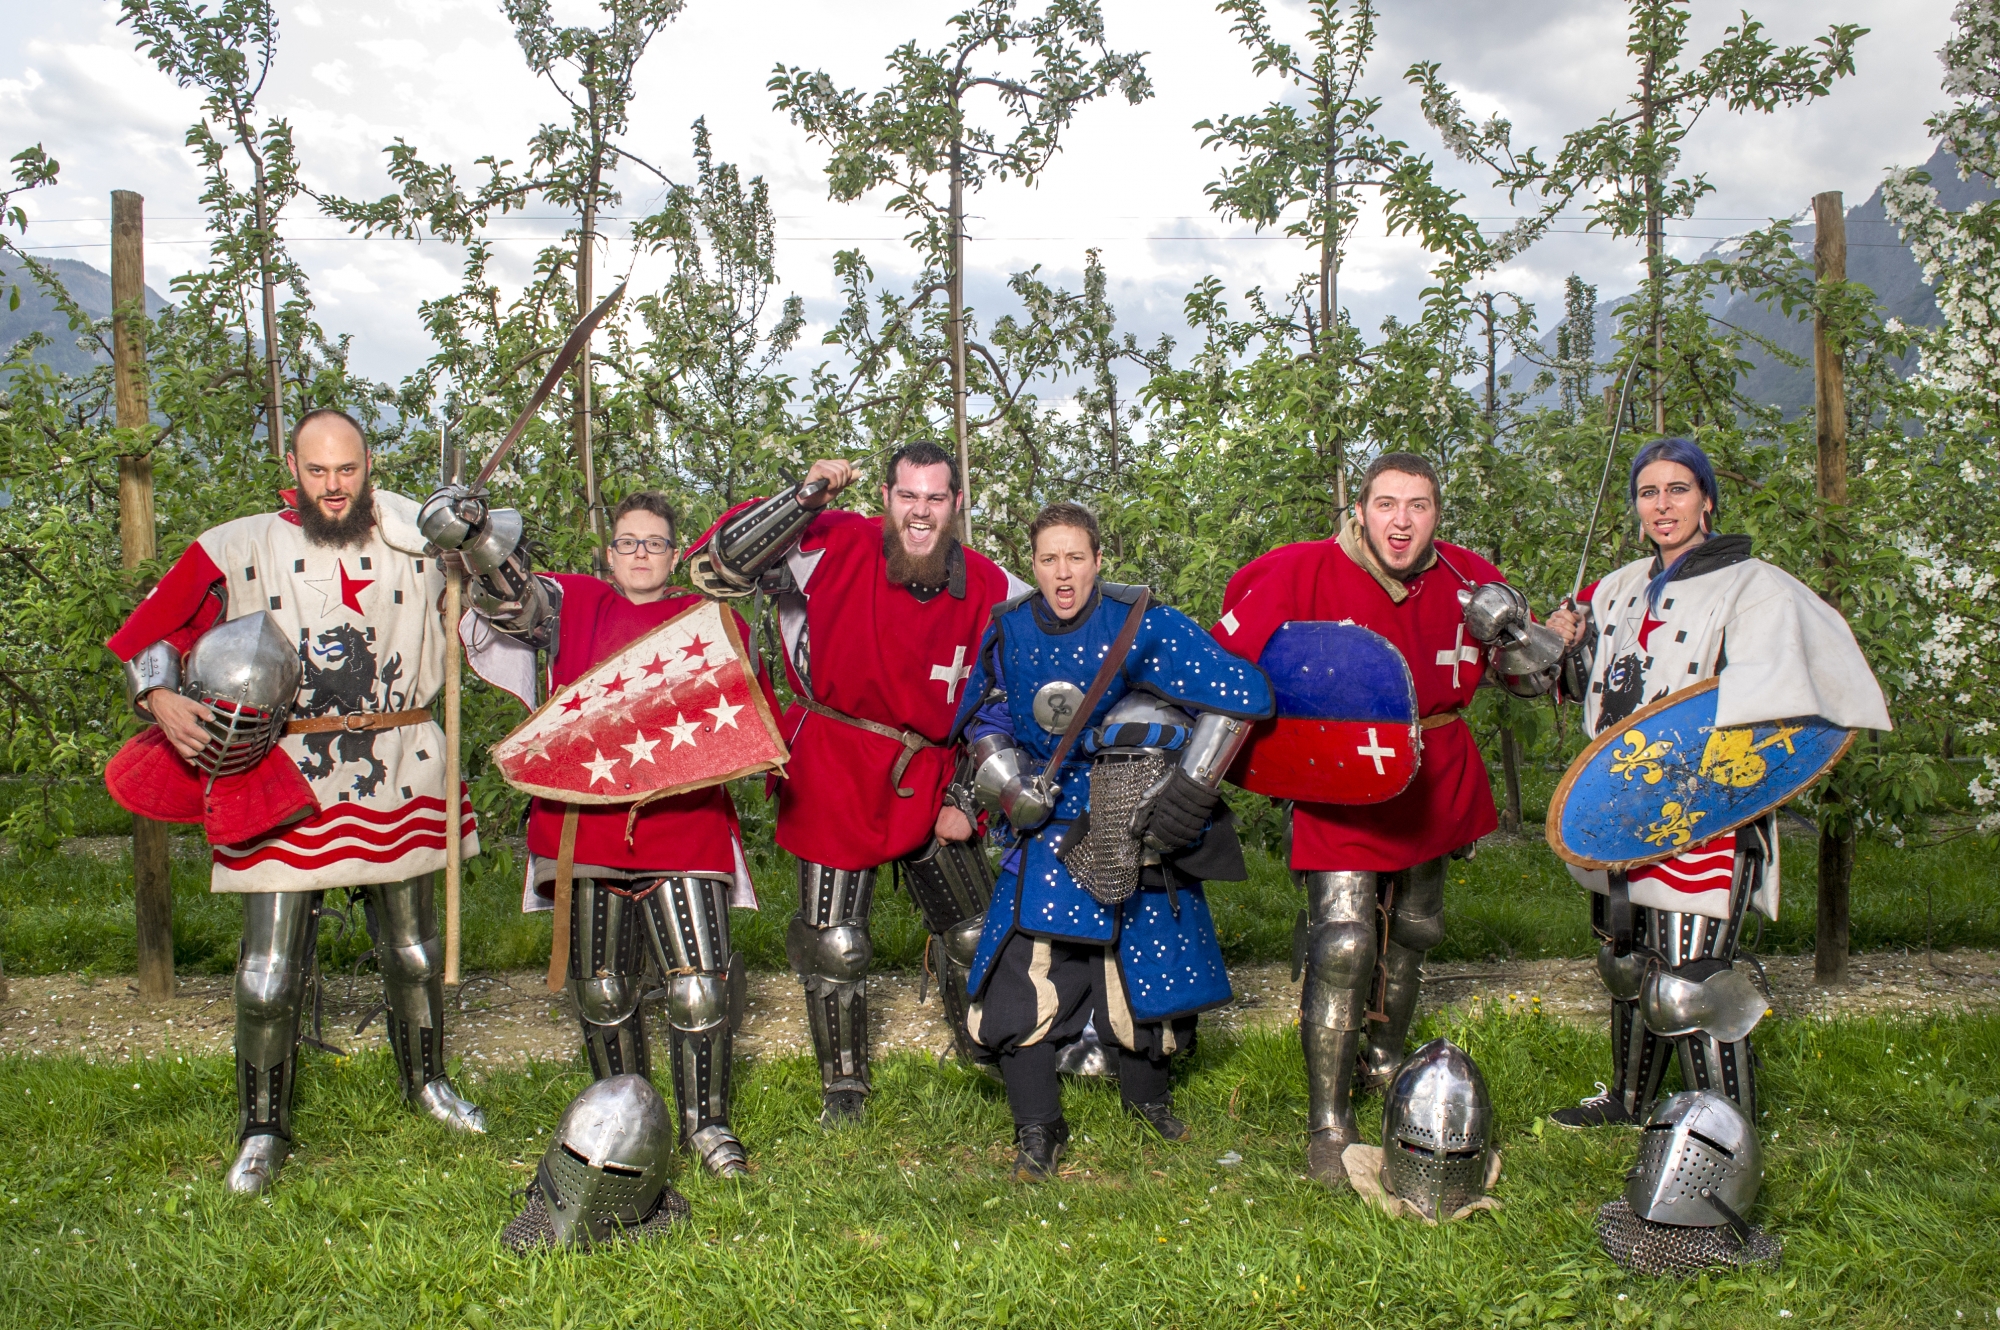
[1500,148,2000,414]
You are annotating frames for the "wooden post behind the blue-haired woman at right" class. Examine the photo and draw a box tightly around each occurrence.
[1812,190,1854,984]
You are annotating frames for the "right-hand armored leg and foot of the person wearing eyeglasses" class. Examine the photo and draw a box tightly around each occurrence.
[644,878,744,1176]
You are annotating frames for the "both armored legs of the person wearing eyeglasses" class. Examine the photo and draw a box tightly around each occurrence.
[570,878,746,1176]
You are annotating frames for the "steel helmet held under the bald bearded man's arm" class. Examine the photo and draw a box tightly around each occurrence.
[180,610,302,776]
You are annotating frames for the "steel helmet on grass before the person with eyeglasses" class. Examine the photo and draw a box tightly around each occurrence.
[500,1076,688,1250]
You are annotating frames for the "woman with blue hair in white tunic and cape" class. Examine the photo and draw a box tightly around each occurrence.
[1548,438,1890,1128]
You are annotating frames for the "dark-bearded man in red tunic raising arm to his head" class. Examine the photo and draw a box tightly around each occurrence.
[688,442,1026,1126]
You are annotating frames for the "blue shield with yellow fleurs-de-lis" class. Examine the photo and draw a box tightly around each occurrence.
[1548,678,1854,872]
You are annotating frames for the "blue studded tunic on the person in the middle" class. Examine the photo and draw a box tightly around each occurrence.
[960,584,1272,1022]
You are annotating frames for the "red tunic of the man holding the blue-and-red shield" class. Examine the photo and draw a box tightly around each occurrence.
[1214,540,1500,872]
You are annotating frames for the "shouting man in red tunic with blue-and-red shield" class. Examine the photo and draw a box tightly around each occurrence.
[1214,452,1560,1188]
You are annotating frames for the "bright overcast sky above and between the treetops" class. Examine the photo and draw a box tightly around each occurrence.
[0,0,1952,390]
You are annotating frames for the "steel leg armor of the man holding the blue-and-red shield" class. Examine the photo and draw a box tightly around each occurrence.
[1298,856,1446,1188]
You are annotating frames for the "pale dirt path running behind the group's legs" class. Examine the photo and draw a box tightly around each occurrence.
[0,950,2000,1068]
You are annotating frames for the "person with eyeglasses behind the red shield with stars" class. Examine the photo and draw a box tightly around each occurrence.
[450,490,776,1178]
